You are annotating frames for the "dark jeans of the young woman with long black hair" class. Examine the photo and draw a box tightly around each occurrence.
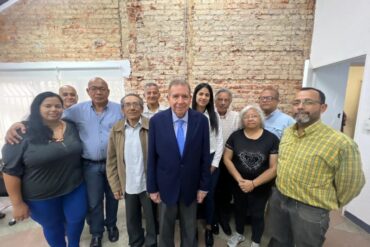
[204,168,220,225]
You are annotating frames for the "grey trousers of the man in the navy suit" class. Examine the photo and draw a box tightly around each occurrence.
[159,201,198,247]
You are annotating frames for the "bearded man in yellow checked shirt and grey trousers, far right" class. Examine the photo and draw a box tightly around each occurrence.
[268,88,365,247]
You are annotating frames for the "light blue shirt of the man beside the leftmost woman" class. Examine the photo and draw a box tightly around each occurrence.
[63,101,123,161]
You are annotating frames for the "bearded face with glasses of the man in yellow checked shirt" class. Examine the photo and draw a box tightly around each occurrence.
[292,90,327,127]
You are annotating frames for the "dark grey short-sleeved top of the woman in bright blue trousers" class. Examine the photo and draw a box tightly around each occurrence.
[2,122,83,200]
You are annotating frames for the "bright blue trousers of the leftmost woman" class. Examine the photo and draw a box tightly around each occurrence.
[26,184,87,247]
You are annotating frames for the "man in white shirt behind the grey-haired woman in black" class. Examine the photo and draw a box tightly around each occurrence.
[213,88,240,235]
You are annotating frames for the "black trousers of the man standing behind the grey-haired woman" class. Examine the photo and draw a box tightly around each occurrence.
[215,157,235,224]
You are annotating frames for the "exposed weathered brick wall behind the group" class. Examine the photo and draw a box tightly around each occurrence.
[0,0,315,111]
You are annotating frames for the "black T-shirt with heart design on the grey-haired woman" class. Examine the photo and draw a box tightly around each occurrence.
[226,129,279,192]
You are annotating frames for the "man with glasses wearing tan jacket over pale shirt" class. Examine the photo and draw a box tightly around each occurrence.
[107,94,157,247]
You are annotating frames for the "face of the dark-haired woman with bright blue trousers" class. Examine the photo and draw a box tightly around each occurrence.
[40,97,63,123]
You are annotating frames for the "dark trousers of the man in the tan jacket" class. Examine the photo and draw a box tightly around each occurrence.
[125,191,157,247]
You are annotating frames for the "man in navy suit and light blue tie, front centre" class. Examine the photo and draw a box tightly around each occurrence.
[147,80,211,247]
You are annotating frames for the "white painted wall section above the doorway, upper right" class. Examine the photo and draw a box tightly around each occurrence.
[310,0,370,68]
